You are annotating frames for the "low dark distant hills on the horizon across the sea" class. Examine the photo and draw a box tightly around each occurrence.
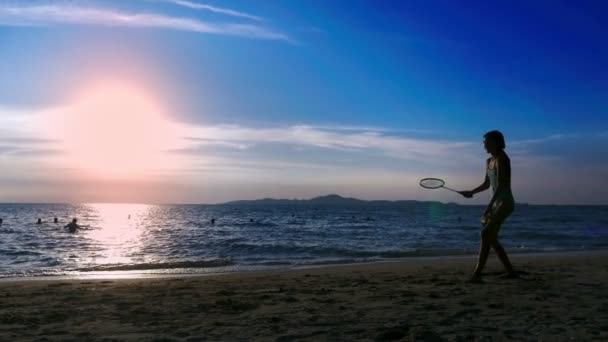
[223,194,444,206]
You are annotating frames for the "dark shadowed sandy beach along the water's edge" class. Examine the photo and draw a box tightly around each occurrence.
[0,252,608,341]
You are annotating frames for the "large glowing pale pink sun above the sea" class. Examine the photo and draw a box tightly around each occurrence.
[53,82,183,177]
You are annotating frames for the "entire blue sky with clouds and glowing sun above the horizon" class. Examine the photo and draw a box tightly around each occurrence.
[0,0,608,204]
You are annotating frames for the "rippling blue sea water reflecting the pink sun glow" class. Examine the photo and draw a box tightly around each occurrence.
[0,202,608,278]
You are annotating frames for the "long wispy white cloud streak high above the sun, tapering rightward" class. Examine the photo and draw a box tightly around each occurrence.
[0,4,290,41]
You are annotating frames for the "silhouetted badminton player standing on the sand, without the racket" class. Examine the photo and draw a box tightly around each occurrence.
[460,131,517,283]
